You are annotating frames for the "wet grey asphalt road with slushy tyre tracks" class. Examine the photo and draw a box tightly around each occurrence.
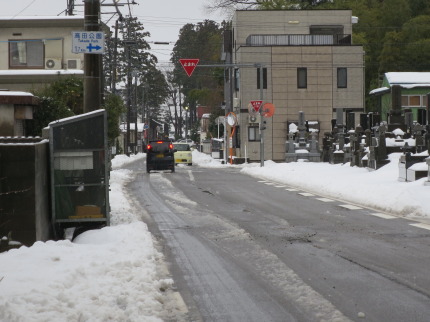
[127,161,430,322]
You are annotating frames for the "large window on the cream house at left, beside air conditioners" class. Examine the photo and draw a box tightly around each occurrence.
[9,40,43,68]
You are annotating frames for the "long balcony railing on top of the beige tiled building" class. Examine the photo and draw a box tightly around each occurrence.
[246,34,351,46]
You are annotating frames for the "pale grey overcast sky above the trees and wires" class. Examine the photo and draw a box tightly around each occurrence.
[0,0,228,65]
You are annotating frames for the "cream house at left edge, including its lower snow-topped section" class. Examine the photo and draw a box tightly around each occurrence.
[0,16,84,136]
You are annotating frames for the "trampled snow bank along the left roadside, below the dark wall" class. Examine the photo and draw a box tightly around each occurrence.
[0,155,173,322]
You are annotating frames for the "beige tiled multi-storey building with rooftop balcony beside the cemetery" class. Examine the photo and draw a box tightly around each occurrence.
[224,10,364,161]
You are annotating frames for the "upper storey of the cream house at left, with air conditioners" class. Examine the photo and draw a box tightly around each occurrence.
[0,16,84,91]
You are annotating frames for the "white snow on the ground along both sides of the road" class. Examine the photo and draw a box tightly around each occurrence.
[0,151,430,322]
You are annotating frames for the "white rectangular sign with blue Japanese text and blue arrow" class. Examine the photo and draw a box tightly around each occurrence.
[72,31,105,54]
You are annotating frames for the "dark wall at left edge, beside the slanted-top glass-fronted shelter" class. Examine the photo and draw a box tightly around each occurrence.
[0,139,52,246]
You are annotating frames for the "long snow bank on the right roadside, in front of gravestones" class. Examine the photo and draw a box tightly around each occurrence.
[241,153,430,217]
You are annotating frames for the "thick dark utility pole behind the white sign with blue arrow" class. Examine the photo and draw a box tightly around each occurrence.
[84,0,102,113]
